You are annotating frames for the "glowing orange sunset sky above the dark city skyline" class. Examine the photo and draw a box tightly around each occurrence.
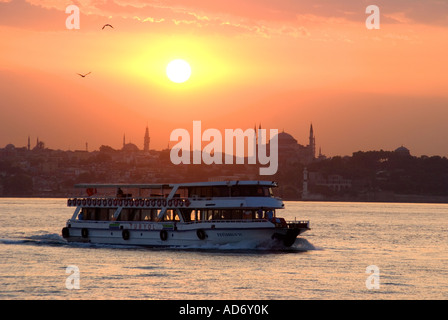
[0,0,448,156]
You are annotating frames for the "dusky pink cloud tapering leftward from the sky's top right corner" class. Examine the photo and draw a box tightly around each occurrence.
[137,0,448,24]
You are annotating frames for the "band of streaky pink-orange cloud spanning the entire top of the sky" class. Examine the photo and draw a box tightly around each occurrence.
[0,0,448,37]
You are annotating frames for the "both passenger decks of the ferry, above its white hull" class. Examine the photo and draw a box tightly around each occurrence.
[68,181,276,223]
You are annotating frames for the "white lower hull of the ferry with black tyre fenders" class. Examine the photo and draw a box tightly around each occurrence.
[63,221,308,248]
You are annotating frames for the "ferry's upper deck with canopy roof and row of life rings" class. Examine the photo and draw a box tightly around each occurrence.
[68,181,284,209]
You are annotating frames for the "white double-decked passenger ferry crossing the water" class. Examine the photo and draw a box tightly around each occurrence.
[62,181,310,247]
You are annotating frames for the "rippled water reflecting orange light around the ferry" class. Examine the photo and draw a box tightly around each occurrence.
[0,199,448,300]
